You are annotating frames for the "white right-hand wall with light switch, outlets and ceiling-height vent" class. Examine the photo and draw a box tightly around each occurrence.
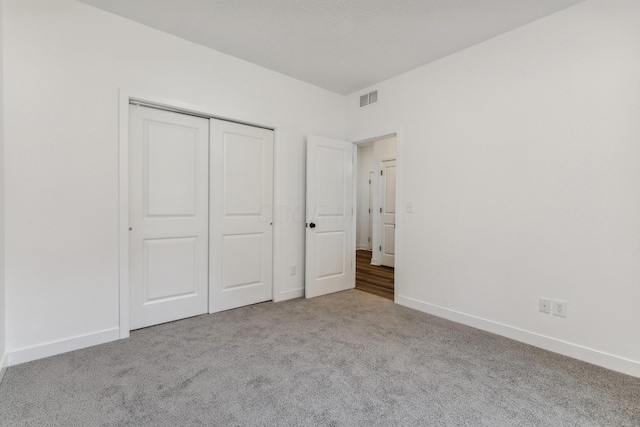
[347,0,640,376]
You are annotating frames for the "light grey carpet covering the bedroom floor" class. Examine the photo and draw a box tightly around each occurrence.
[0,290,640,427]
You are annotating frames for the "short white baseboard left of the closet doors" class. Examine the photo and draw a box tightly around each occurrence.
[8,328,120,366]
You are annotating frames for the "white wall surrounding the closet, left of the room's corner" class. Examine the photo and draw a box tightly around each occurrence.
[5,0,345,363]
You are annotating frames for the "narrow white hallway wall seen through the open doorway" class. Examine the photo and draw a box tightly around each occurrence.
[356,144,373,249]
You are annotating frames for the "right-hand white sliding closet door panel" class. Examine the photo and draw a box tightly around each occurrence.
[209,119,274,313]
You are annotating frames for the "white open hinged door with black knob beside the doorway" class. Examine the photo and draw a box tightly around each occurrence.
[305,135,355,298]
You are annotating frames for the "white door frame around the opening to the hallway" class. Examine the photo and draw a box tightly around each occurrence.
[350,127,405,303]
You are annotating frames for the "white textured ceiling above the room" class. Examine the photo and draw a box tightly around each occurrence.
[76,0,584,95]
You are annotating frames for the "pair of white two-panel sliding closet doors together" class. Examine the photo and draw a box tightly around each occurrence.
[129,105,274,329]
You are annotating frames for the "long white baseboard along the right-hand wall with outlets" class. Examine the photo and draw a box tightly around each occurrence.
[395,295,640,377]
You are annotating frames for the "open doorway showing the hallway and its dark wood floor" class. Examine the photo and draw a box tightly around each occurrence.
[355,135,397,300]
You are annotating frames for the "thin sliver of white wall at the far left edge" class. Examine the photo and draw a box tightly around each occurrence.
[0,0,7,381]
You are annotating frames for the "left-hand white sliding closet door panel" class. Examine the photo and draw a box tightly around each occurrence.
[129,105,209,329]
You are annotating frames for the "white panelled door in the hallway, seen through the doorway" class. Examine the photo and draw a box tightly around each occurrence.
[380,159,396,267]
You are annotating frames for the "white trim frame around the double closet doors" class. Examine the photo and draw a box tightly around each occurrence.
[118,88,282,338]
